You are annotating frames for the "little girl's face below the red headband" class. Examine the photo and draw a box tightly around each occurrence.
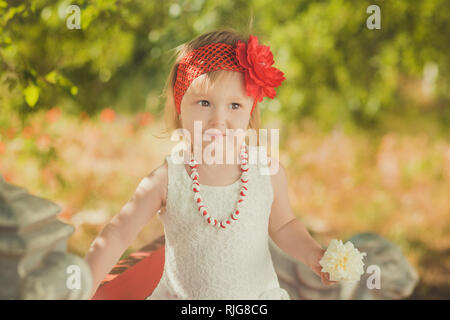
[181,70,253,161]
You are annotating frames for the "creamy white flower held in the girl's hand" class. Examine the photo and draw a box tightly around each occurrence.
[319,240,366,282]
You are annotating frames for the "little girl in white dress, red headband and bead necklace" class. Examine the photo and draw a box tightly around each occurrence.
[86,29,334,299]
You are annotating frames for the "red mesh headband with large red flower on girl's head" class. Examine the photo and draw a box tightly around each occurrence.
[174,35,285,114]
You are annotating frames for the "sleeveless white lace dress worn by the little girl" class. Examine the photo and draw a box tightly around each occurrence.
[146,155,290,300]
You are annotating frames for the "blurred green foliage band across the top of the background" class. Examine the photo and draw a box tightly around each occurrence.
[0,0,450,132]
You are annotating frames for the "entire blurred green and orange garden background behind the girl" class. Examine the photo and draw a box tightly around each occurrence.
[0,0,450,299]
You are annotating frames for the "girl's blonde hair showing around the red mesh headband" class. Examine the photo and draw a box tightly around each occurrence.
[163,28,261,145]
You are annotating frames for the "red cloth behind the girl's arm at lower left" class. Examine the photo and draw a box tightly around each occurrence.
[92,245,164,300]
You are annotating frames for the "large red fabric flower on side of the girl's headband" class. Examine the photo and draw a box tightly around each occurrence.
[236,35,286,103]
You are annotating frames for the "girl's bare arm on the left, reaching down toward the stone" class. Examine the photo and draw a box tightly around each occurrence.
[85,163,167,298]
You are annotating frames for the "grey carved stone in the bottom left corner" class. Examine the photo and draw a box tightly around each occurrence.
[0,175,92,300]
